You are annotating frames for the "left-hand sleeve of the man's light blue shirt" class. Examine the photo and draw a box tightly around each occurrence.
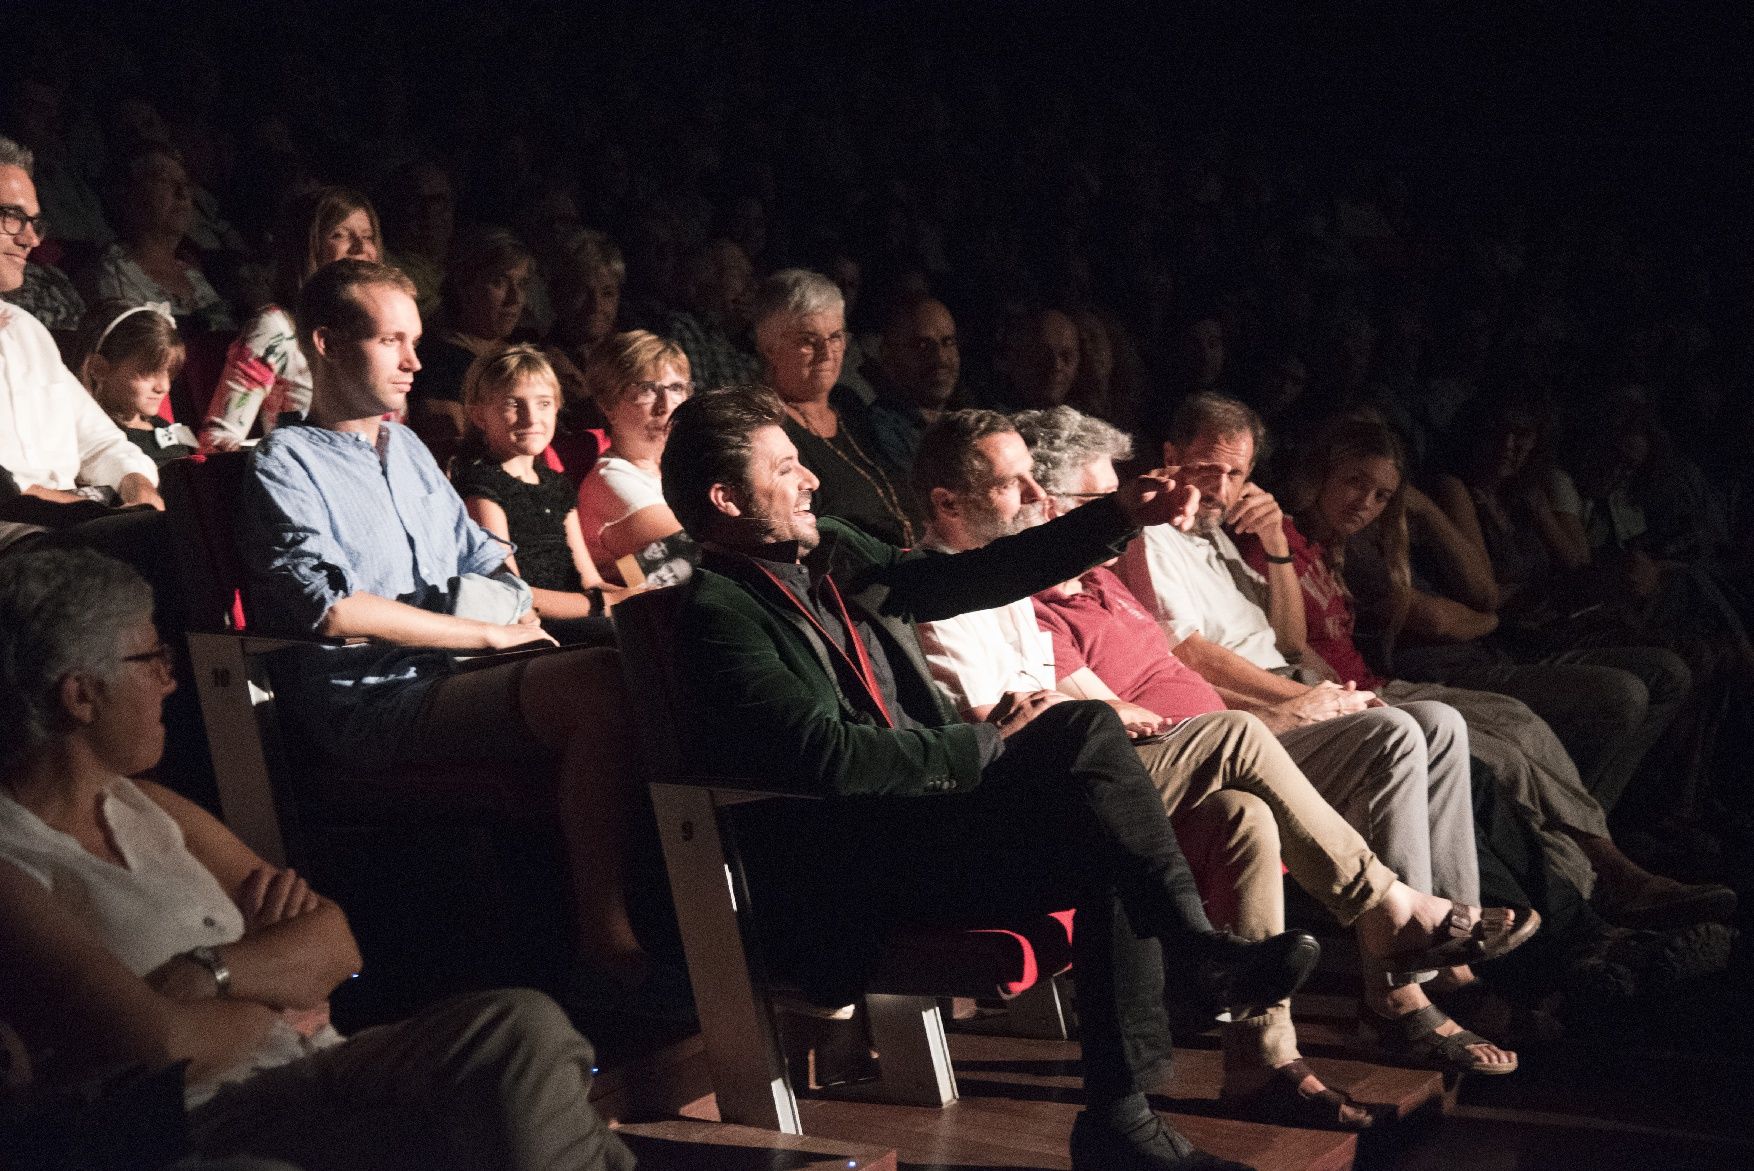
[239,449,356,633]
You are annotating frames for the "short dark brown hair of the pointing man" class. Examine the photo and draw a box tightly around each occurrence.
[658,386,786,542]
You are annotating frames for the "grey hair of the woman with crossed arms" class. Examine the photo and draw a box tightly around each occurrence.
[0,549,153,775]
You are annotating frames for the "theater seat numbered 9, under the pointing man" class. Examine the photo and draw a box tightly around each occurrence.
[616,587,1072,1134]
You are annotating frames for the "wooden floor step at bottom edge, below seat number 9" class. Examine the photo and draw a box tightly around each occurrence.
[616,1118,896,1171]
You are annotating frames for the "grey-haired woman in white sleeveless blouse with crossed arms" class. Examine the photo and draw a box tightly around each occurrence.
[0,550,633,1171]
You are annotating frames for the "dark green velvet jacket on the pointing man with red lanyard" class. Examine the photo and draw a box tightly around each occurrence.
[674,500,1137,798]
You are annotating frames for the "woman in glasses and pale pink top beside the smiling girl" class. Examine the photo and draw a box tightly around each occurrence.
[579,330,696,586]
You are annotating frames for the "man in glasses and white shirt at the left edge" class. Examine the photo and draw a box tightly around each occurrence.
[0,138,165,528]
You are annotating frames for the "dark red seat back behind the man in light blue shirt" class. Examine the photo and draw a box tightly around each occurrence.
[158,451,249,631]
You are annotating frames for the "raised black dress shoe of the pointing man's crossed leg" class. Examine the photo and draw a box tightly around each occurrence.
[1163,931,1321,1029]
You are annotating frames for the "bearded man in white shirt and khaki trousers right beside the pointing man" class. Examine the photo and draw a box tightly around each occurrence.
[912,407,1515,1100]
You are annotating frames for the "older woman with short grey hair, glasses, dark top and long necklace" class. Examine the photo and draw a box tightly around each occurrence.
[751,268,919,545]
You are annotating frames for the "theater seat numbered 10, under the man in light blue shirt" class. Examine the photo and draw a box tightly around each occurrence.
[161,452,570,1015]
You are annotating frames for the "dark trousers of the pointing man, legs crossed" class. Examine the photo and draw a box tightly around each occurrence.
[751,701,1210,1097]
